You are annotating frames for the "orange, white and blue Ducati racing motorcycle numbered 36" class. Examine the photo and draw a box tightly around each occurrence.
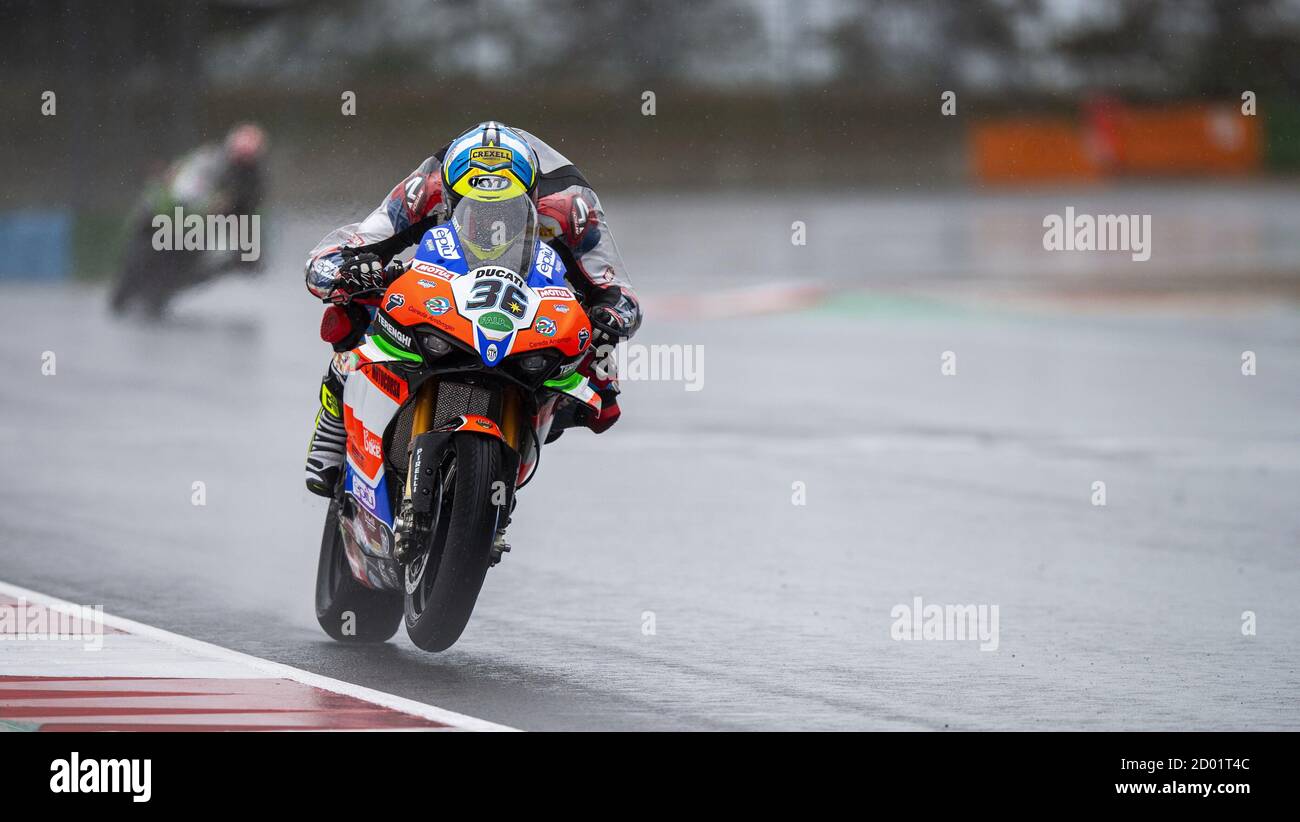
[316,191,601,652]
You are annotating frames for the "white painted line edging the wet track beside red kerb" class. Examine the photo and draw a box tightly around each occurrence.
[0,581,517,731]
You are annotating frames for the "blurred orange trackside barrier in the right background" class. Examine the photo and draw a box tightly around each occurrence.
[969,100,1264,182]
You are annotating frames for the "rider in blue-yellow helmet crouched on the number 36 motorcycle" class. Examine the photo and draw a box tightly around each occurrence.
[307,121,641,497]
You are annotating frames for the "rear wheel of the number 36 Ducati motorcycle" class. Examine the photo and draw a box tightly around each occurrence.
[316,501,402,643]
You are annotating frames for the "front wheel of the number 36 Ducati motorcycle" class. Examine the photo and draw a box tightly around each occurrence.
[406,434,501,652]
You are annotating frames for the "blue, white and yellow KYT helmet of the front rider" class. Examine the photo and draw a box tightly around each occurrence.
[442,121,538,211]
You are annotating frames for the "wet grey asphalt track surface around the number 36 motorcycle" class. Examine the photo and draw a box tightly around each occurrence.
[0,190,1300,730]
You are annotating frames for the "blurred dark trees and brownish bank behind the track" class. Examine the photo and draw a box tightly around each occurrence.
[0,0,1300,208]
